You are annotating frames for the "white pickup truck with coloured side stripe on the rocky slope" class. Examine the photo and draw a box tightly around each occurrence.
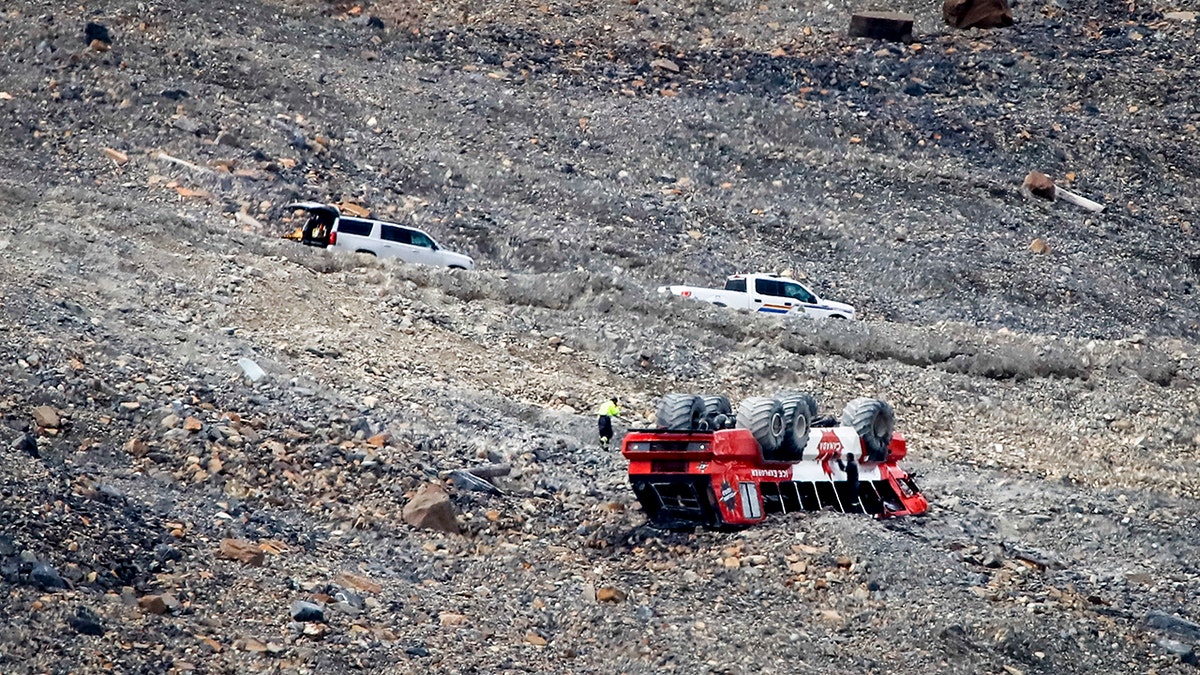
[659,274,854,318]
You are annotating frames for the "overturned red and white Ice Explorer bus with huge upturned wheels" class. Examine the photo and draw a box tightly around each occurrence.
[622,394,928,527]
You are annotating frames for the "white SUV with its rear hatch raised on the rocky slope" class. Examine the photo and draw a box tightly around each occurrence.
[286,202,475,269]
